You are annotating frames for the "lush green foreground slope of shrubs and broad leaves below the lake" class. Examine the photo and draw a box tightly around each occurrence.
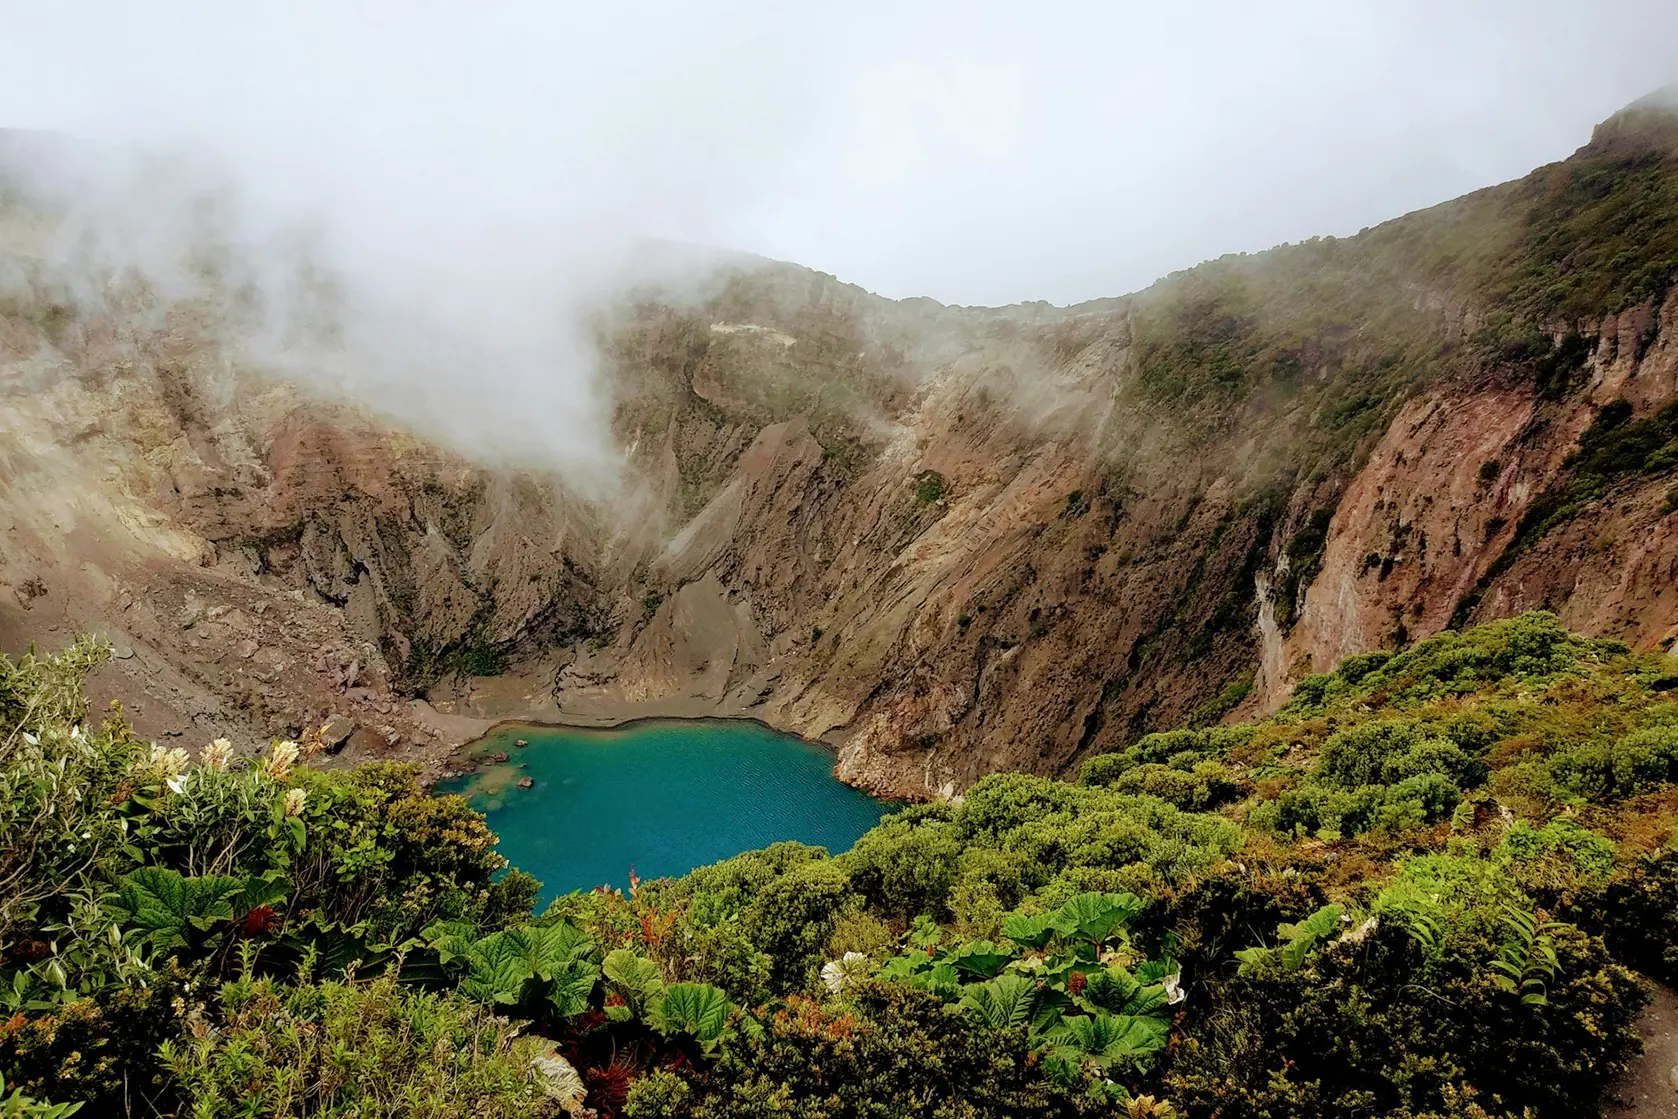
[0,612,1678,1119]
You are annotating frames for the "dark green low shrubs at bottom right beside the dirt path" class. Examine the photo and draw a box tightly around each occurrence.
[1166,921,1643,1116]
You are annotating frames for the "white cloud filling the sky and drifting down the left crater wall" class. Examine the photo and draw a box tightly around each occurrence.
[0,0,1678,481]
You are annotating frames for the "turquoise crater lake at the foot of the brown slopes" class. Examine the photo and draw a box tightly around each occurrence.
[438,720,894,899]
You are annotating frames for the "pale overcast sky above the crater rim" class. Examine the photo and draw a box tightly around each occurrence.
[0,0,1678,304]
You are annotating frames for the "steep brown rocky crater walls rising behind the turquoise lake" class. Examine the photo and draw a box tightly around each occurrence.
[0,93,1678,797]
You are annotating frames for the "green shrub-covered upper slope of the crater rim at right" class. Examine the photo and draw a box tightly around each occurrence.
[1107,100,1678,487]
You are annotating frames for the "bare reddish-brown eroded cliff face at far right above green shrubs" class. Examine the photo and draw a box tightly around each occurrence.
[1259,292,1678,706]
